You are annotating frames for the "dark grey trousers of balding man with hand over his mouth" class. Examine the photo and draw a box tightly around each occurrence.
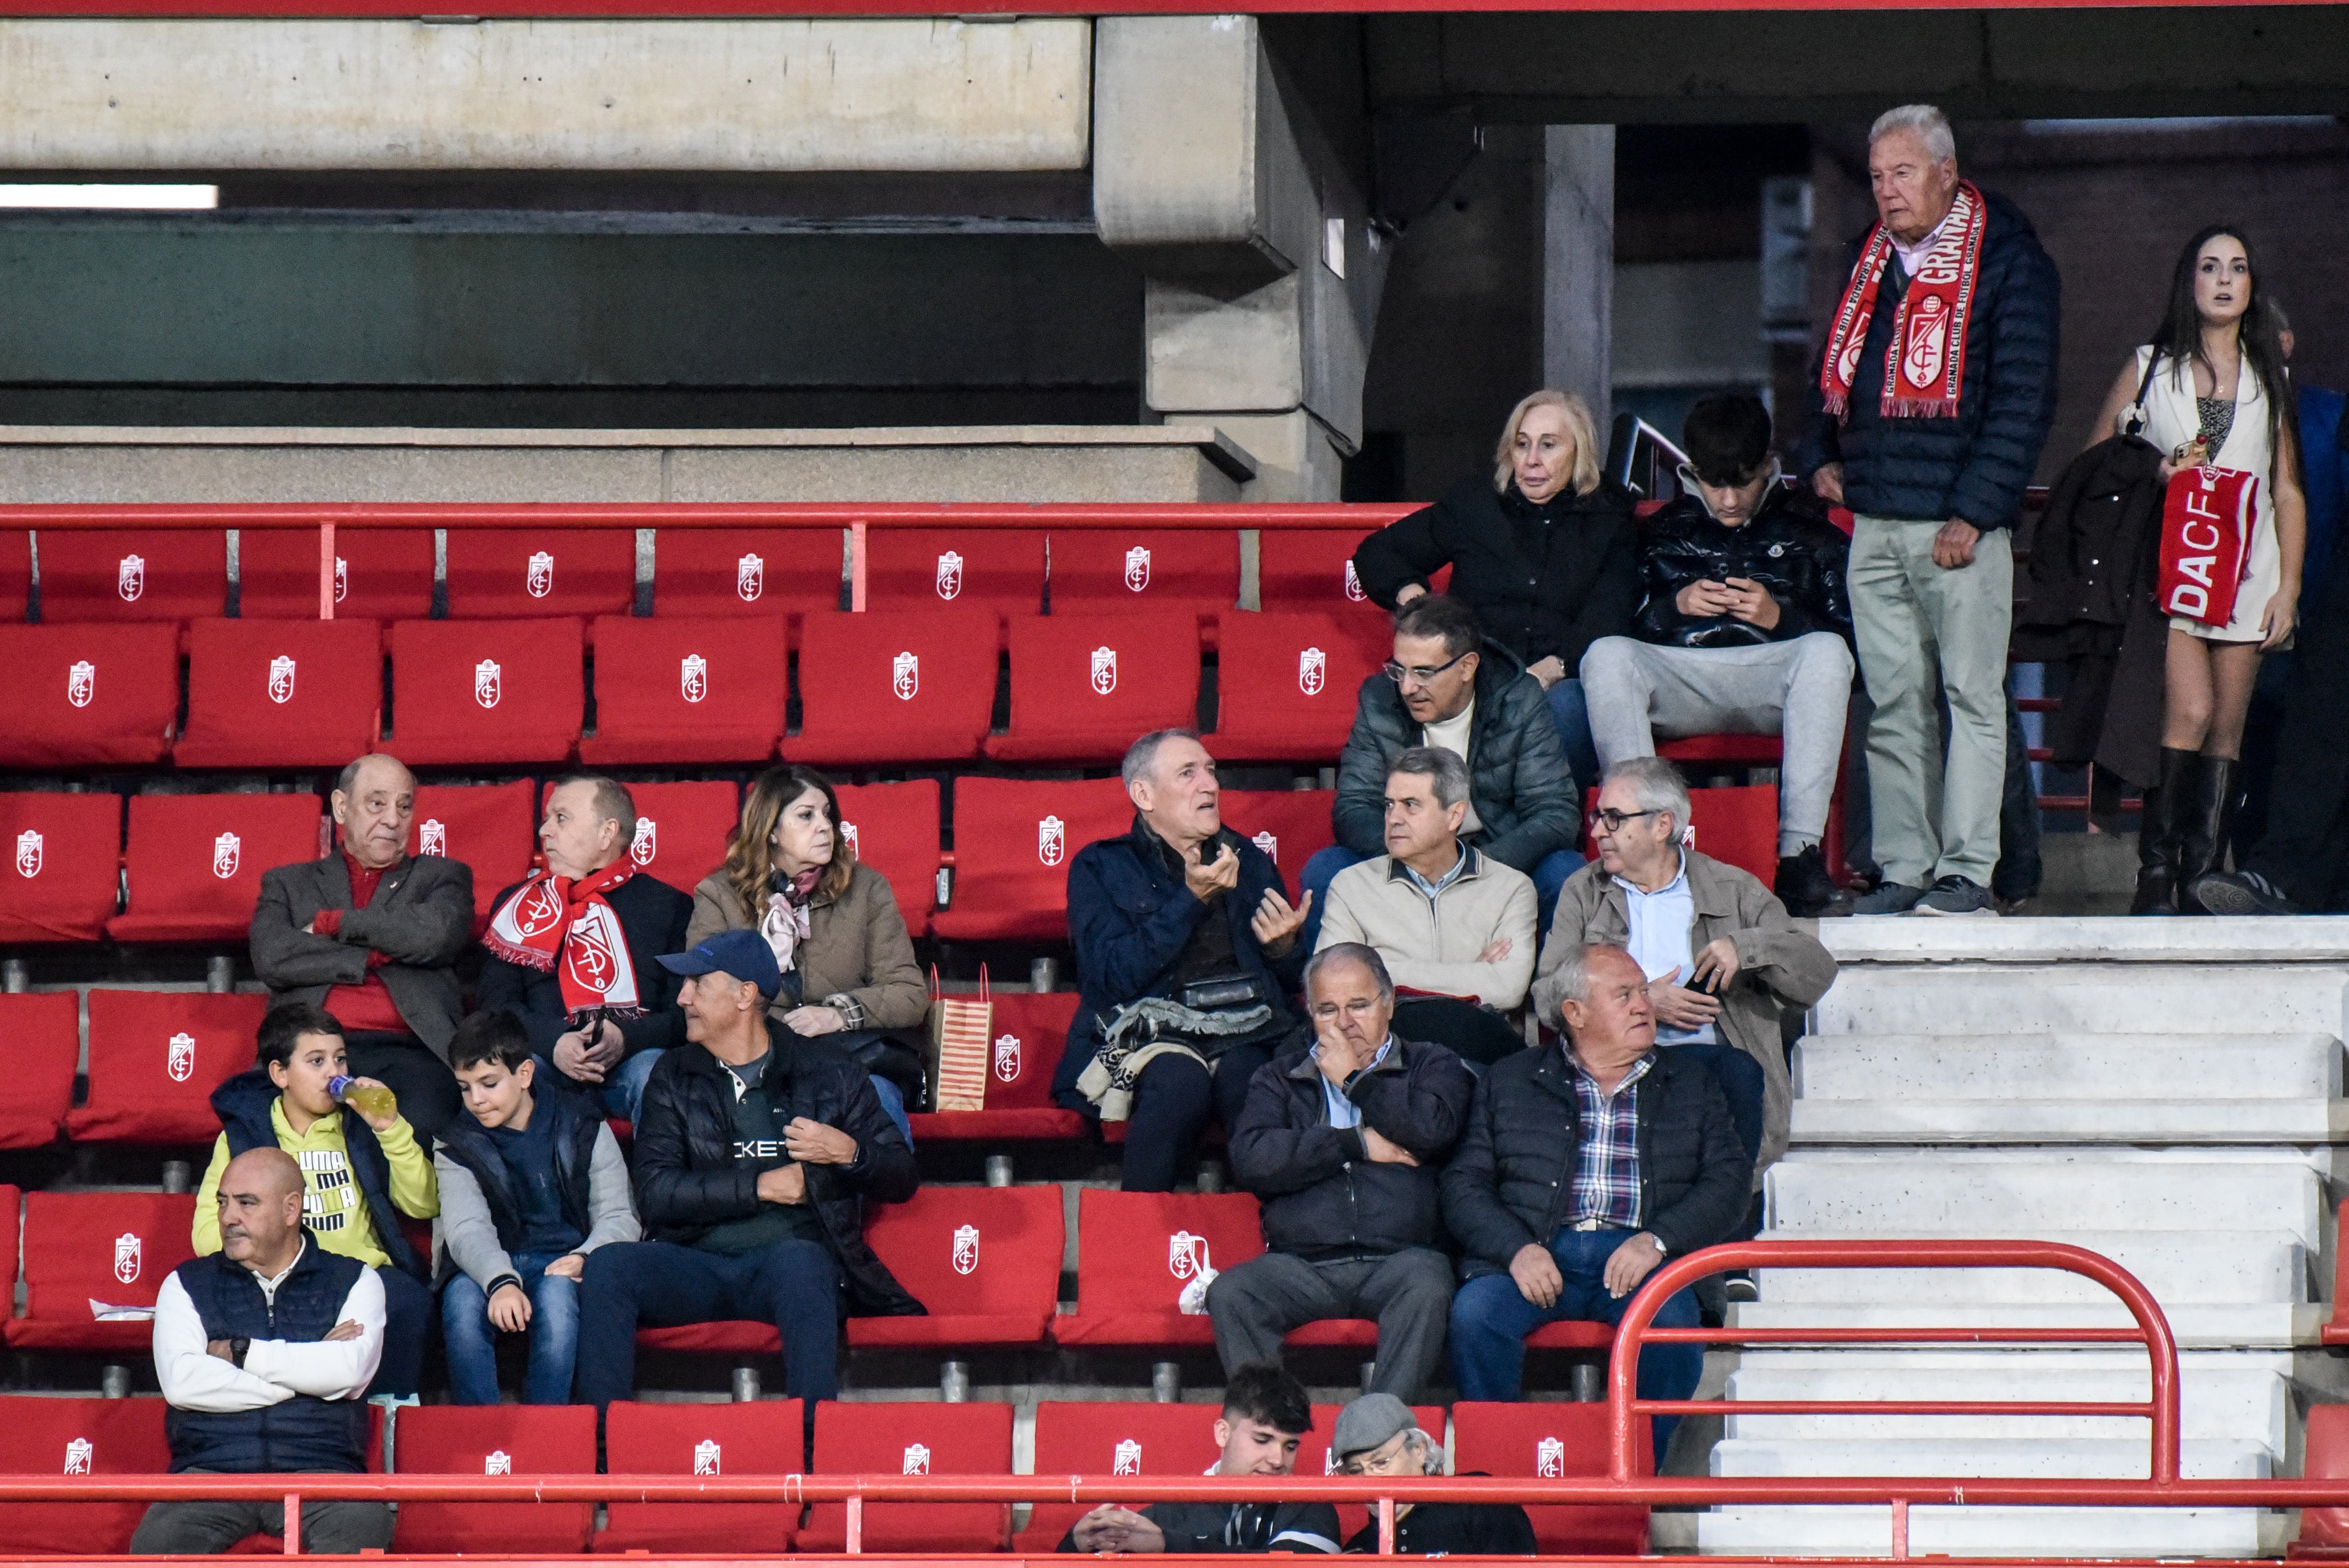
[1207,1246,1452,1404]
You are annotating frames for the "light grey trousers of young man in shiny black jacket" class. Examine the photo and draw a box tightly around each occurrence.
[1583,632,1851,857]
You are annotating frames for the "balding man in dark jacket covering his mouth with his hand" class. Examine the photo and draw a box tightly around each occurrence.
[1207,941,1475,1401]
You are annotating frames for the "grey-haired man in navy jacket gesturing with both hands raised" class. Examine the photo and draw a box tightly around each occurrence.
[1052,730,1313,1193]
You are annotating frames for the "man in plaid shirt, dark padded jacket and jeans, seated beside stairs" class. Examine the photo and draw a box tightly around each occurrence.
[1445,946,1752,1458]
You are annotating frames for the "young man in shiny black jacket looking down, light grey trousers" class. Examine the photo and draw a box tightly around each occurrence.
[1583,392,1851,918]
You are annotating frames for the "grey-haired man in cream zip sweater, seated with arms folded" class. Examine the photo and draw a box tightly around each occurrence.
[1316,747,1536,1063]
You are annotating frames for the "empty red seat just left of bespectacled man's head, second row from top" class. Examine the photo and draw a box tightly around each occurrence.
[1207,613,1393,763]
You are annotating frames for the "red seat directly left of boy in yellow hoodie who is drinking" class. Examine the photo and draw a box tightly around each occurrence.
[66,986,270,1143]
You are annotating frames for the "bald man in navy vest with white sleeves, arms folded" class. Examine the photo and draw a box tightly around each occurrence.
[131,1148,392,1556]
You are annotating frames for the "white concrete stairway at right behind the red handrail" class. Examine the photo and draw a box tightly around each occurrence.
[1698,918,2349,1556]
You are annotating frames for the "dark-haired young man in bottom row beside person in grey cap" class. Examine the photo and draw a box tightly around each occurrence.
[1059,1361,1337,1552]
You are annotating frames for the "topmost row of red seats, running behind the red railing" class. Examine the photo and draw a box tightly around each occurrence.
[0,526,1367,622]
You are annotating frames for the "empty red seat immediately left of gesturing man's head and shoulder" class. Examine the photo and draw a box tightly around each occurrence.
[930,775,1135,941]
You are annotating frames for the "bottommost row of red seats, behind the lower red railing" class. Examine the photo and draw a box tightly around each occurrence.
[0,1395,1647,1556]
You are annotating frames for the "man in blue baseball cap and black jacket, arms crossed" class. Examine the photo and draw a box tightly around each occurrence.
[578,930,923,1427]
